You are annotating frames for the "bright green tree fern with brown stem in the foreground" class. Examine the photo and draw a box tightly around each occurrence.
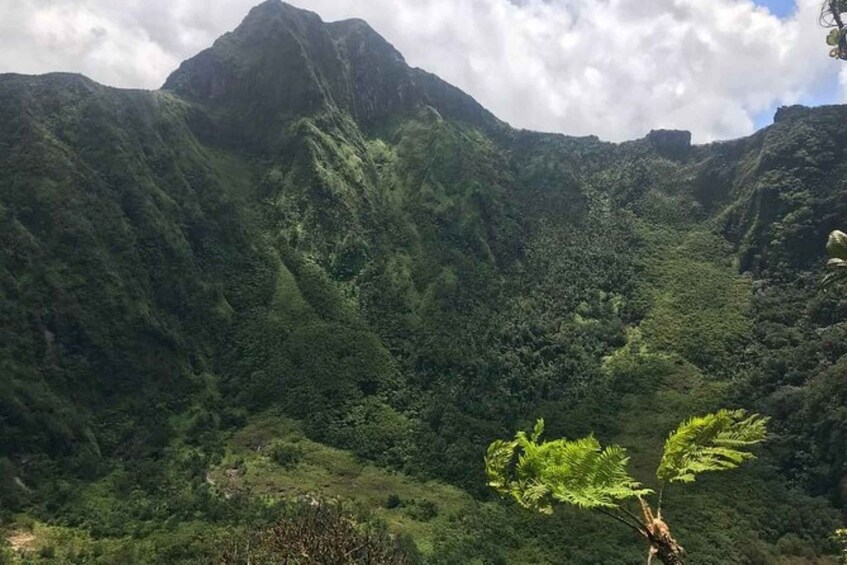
[485,410,768,565]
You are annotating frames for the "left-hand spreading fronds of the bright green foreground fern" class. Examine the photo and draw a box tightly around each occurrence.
[485,420,652,514]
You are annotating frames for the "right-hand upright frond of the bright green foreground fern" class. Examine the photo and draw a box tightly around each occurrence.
[656,410,768,483]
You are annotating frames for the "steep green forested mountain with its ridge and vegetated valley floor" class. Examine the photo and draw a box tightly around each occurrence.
[0,0,847,563]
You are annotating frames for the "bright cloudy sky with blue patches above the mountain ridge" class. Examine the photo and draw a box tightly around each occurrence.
[0,0,847,141]
